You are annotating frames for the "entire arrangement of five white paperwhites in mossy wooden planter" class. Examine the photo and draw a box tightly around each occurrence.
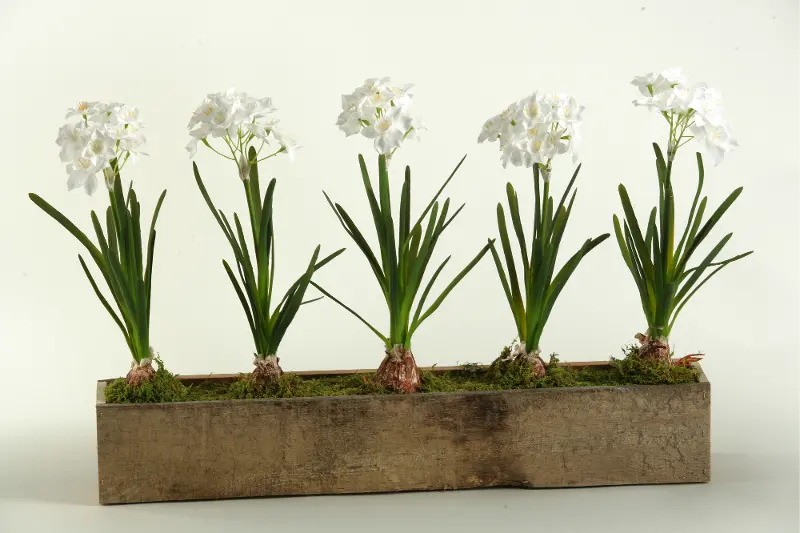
[40,67,751,503]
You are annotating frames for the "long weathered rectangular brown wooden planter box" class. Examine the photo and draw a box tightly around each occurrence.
[97,363,711,504]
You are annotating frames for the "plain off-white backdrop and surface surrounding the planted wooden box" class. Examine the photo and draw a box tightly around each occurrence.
[0,0,800,532]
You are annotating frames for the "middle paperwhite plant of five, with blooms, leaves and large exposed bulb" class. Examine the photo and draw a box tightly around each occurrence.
[312,78,490,392]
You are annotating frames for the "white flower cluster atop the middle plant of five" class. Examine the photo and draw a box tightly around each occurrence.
[336,78,425,155]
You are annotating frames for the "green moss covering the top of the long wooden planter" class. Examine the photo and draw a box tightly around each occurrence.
[106,346,698,403]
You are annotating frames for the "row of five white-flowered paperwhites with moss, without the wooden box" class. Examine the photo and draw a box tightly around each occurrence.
[30,72,752,402]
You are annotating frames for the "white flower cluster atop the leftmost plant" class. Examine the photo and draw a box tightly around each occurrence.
[56,102,145,195]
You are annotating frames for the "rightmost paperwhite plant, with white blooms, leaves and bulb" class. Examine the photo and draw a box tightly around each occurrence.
[614,69,753,362]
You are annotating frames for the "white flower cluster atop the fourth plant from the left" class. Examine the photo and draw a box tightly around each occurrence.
[478,92,583,174]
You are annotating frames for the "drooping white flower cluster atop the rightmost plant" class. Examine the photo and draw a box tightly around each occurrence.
[631,69,739,165]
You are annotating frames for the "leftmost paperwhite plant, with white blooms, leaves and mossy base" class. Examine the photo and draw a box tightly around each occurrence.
[29,101,181,400]
